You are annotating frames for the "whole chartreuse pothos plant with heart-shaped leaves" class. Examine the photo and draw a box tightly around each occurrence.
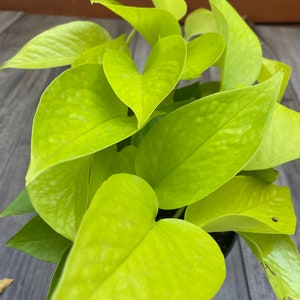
[1,0,300,300]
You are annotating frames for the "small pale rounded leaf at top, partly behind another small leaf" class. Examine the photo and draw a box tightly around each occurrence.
[184,8,218,40]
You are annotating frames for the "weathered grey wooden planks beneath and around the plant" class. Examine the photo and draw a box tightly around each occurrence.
[0,11,300,300]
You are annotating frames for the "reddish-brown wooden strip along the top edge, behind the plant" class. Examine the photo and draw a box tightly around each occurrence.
[0,0,300,23]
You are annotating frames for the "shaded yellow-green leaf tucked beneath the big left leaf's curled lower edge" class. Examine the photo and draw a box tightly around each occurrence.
[27,156,92,240]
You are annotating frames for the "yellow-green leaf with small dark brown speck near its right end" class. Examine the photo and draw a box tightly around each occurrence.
[185,176,296,234]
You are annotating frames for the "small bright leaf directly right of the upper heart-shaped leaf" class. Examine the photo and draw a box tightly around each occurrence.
[182,33,225,80]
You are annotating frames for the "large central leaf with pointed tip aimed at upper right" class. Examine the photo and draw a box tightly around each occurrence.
[136,74,282,209]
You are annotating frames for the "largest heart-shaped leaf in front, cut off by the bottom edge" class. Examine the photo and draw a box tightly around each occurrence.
[52,174,225,300]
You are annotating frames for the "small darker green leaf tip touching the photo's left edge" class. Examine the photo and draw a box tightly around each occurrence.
[0,189,35,218]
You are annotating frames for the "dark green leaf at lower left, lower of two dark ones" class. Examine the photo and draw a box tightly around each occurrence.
[6,216,71,263]
